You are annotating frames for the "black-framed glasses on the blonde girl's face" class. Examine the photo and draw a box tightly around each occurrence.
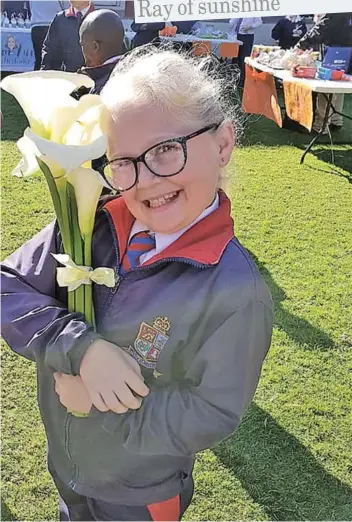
[99,122,222,192]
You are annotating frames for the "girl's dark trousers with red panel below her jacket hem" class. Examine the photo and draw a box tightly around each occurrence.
[48,459,194,522]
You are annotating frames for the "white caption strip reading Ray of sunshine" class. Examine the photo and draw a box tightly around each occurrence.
[134,0,352,23]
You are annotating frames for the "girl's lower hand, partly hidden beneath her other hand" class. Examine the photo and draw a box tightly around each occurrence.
[54,373,93,413]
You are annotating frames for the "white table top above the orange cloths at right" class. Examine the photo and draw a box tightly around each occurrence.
[245,58,352,94]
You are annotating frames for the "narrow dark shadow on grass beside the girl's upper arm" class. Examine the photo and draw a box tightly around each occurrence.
[248,250,335,350]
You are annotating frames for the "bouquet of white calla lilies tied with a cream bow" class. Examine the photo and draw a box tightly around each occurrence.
[0,71,114,324]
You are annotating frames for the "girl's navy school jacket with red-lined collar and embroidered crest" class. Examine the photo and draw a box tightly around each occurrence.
[1,192,272,505]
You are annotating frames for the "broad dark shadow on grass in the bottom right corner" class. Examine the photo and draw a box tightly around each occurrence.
[213,403,352,520]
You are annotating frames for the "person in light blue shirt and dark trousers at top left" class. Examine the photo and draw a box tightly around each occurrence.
[29,0,63,71]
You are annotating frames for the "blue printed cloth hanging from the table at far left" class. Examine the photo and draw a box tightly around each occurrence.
[1,27,35,72]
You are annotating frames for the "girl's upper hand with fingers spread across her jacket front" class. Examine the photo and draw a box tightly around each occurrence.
[80,339,149,413]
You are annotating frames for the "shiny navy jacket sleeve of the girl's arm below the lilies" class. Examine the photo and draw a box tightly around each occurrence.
[1,224,99,374]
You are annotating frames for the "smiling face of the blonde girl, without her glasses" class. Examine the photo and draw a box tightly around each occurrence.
[108,105,234,234]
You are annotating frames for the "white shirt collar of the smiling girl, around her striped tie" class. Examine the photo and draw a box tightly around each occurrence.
[129,194,219,265]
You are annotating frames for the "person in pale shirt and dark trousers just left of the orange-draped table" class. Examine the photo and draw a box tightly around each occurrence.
[229,18,263,86]
